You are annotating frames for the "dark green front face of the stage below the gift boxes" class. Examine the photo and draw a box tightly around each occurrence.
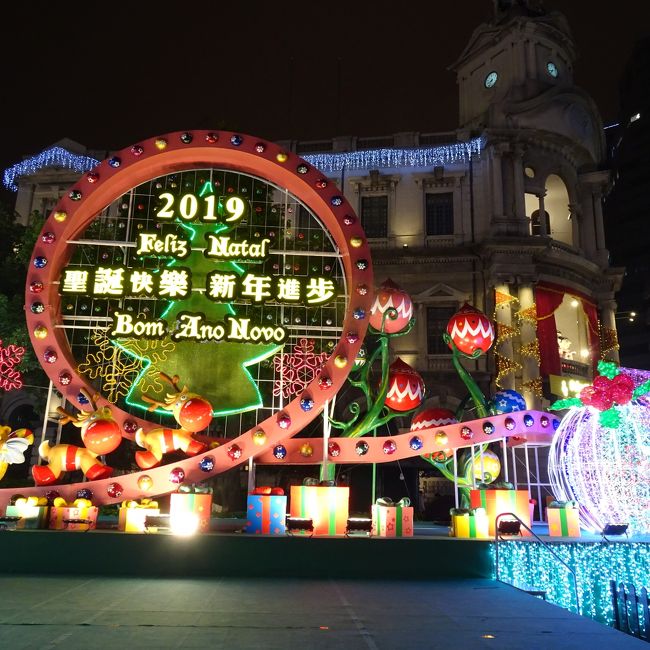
[0,530,493,580]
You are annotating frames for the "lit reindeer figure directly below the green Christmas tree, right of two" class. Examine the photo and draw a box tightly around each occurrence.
[135,372,212,469]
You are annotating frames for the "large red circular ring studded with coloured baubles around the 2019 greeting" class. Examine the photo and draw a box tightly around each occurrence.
[25,131,373,498]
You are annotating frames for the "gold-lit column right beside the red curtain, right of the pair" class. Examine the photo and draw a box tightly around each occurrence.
[517,282,542,409]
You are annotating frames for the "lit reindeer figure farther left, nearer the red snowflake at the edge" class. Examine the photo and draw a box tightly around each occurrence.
[32,389,122,485]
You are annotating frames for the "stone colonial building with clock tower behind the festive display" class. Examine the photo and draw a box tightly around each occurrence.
[5,2,623,416]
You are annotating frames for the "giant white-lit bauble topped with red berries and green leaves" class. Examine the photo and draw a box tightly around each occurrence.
[549,362,650,534]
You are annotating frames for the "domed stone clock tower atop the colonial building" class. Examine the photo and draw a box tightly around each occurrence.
[452,0,604,161]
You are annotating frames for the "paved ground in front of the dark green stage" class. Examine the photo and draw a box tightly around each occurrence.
[0,576,648,650]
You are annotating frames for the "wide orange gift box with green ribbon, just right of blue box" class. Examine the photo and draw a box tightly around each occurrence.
[290,485,350,535]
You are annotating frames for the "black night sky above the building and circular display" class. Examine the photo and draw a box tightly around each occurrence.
[0,0,649,190]
